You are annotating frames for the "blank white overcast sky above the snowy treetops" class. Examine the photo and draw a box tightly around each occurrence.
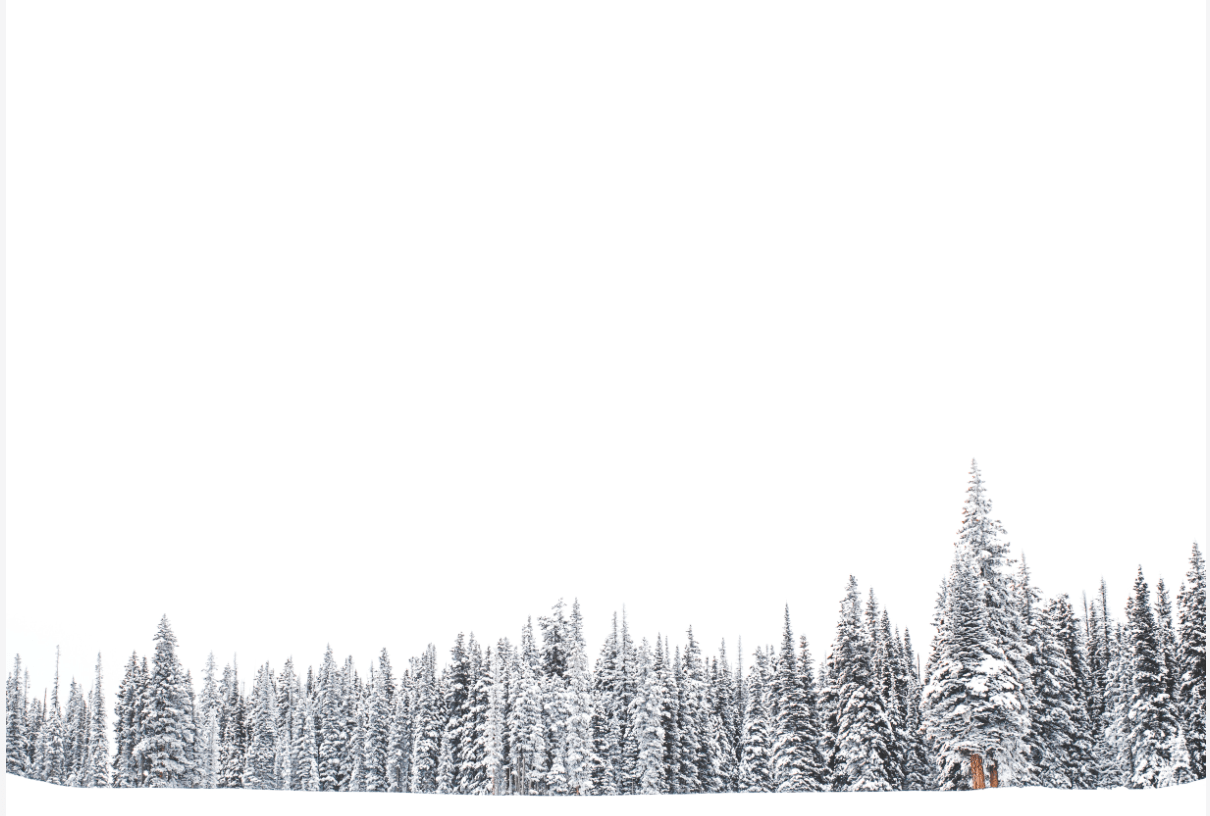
[5,0,1206,695]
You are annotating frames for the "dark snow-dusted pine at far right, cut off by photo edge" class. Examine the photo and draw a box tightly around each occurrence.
[1176,544,1206,780]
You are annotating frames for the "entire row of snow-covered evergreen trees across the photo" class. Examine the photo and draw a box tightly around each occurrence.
[5,462,1206,795]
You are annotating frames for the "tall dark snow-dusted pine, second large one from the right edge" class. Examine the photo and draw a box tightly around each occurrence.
[1125,567,1192,788]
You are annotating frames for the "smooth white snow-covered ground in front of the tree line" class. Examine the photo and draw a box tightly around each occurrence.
[5,774,1206,816]
